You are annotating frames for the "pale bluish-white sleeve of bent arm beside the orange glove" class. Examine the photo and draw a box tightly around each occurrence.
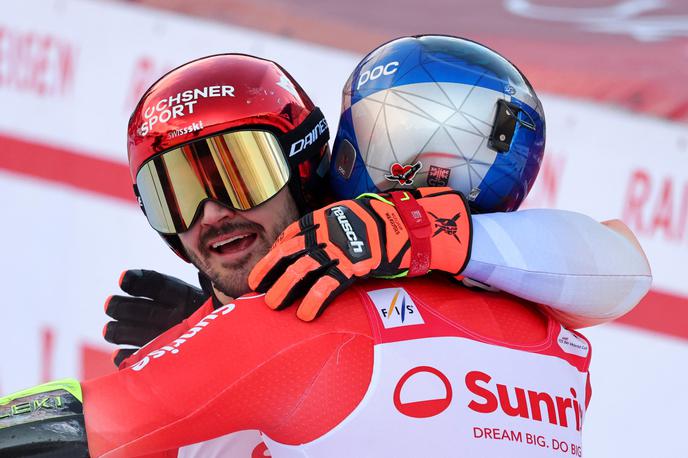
[463,210,652,327]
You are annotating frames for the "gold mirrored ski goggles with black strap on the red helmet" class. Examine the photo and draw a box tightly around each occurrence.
[134,108,329,234]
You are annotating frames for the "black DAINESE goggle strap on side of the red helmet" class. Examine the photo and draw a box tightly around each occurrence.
[280,107,330,164]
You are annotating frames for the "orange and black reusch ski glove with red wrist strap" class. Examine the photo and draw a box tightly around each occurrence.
[249,188,472,321]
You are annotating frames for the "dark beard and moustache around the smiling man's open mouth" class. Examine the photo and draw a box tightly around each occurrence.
[187,208,298,298]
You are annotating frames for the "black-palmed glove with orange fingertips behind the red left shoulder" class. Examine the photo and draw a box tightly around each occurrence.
[103,269,210,367]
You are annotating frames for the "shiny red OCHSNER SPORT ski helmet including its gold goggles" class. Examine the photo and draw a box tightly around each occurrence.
[127,54,329,261]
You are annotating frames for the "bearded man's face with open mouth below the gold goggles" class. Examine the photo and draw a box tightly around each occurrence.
[179,187,299,298]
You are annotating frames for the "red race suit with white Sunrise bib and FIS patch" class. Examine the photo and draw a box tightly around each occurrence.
[83,276,591,458]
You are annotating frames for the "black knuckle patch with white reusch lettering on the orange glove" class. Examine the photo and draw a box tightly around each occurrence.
[327,206,370,262]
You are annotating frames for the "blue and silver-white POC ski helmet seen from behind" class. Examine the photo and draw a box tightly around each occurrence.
[330,35,545,212]
